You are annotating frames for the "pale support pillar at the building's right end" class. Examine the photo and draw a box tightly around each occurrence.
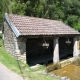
[73,37,79,58]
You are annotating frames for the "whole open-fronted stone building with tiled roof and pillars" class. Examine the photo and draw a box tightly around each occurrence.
[3,13,80,64]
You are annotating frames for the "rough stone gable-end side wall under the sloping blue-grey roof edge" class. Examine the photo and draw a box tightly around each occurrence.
[4,22,16,55]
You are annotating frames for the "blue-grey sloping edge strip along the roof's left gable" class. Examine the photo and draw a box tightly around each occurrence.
[4,13,21,37]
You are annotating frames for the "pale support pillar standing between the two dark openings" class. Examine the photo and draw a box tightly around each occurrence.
[53,37,59,63]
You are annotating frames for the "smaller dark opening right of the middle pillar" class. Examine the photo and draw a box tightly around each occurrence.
[59,37,73,60]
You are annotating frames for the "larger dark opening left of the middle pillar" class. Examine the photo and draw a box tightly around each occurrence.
[26,38,53,66]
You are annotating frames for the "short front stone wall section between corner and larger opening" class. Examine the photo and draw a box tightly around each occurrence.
[15,37,27,63]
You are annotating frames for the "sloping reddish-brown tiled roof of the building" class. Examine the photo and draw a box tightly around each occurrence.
[6,14,80,35]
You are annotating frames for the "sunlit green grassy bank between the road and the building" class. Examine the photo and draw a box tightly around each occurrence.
[0,35,59,80]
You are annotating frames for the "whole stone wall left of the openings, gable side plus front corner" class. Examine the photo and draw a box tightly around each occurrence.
[3,21,26,63]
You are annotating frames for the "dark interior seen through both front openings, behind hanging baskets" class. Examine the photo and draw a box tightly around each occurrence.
[26,37,73,65]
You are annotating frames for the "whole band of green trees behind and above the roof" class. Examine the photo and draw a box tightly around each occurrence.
[0,0,80,31]
